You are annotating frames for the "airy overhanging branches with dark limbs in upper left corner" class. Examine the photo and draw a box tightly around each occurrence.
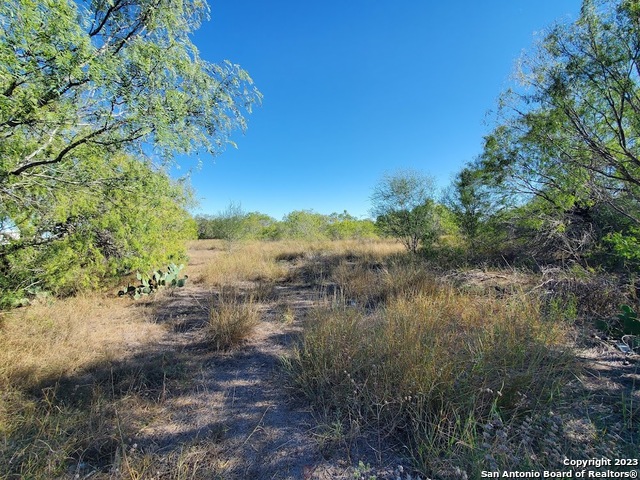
[0,0,259,189]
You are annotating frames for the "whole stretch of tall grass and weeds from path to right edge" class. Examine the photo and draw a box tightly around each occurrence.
[287,248,638,478]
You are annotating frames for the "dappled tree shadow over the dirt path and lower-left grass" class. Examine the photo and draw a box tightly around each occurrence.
[0,285,340,479]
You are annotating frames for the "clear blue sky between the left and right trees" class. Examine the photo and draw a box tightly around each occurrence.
[182,0,581,219]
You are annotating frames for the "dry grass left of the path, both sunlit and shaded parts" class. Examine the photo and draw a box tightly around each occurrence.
[0,288,228,480]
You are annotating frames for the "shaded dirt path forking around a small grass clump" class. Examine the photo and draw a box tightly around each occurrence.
[131,284,400,480]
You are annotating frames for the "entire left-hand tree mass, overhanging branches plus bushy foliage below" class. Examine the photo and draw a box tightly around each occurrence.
[0,0,260,304]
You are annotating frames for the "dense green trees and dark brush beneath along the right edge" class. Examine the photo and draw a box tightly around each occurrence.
[453,0,640,271]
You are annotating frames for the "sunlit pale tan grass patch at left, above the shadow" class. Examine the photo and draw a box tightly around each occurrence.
[0,294,166,388]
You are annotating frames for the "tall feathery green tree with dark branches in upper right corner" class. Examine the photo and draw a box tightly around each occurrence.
[481,0,640,258]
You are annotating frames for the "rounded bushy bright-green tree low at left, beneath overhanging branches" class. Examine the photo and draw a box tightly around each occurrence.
[0,154,195,306]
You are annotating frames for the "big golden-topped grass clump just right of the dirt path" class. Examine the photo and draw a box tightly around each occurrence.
[289,279,572,474]
